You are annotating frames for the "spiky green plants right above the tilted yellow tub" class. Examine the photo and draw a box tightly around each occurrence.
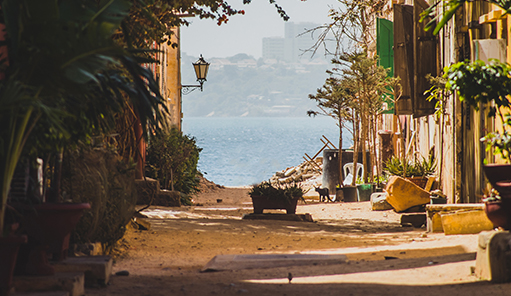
[384,154,436,178]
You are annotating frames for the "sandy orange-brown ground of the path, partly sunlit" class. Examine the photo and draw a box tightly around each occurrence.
[86,188,511,296]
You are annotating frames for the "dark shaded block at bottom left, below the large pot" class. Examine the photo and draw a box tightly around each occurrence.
[13,272,85,296]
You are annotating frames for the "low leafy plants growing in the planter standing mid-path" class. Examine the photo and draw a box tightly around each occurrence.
[248,181,304,201]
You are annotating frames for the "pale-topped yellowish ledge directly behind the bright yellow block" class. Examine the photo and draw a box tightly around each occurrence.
[426,204,484,232]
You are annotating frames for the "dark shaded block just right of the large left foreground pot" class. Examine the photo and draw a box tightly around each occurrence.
[53,256,113,287]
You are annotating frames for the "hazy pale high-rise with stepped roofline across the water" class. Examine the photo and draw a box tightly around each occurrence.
[263,22,319,63]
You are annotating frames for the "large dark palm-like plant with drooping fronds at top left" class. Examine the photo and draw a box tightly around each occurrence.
[0,0,169,235]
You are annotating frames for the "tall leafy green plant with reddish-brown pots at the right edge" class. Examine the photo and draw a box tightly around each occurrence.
[444,60,511,229]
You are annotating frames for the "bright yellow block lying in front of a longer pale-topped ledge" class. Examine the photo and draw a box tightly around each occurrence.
[441,210,493,235]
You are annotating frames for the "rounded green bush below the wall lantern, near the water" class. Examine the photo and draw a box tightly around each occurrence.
[146,128,202,194]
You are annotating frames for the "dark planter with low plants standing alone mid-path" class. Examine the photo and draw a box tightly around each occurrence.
[248,181,304,214]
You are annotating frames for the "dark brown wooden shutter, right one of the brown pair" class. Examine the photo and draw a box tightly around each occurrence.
[412,0,437,118]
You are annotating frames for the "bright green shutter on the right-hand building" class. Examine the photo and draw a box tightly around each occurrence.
[376,18,394,114]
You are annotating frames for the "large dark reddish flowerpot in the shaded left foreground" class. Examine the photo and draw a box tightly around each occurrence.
[14,203,90,275]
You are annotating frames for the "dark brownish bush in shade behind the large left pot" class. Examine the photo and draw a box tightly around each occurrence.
[62,148,137,253]
